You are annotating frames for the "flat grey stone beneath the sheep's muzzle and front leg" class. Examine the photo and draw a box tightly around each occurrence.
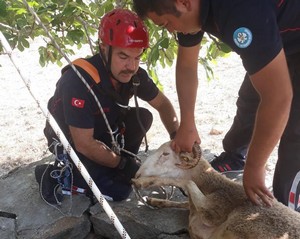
[90,191,189,239]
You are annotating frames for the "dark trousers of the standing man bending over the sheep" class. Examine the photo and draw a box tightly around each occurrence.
[223,53,300,209]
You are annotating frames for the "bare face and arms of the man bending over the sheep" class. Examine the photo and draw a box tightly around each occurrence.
[147,0,293,206]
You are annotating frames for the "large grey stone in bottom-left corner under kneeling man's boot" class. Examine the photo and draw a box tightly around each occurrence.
[0,158,91,239]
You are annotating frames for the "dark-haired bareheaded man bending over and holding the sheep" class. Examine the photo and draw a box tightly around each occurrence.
[133,0,300,209]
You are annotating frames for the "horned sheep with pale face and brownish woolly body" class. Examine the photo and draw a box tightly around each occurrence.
[132,142,300,239]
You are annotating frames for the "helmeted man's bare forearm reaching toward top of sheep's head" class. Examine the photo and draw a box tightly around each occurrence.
[148,91,179,135]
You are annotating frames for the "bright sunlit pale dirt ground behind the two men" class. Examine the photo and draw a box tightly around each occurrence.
[0,38,276,190]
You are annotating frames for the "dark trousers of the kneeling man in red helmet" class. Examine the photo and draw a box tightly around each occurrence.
[73,108,153,201]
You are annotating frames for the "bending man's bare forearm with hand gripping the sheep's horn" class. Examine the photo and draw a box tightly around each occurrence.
[172,45,201,152]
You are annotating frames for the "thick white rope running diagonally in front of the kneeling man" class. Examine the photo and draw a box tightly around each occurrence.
[0,28,130,239]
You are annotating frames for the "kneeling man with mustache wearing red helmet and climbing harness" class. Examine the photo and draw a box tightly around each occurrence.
[35,9,178,204]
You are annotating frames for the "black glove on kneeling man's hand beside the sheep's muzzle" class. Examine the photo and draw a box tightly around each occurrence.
[117,155,141,182]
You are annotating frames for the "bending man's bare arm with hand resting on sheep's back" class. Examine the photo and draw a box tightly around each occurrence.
[243,50,293,205]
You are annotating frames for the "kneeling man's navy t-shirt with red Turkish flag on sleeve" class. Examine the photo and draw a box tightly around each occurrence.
[48,54,159,140]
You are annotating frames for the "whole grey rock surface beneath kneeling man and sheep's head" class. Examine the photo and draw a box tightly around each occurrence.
[0,158,189,239]
